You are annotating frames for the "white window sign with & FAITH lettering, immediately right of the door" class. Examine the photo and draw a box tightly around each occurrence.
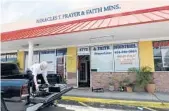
[91,45,114,72]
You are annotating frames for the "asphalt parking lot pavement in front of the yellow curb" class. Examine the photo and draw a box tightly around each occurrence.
[3,100,169,111]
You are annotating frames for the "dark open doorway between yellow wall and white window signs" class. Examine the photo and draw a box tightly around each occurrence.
[78,55,90,87]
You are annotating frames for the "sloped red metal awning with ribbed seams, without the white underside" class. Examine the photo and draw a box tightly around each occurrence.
[1,6,169,42]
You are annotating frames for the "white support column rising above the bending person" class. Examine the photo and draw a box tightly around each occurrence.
[28,41,33,67]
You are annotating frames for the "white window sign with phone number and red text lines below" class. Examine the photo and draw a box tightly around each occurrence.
[114,43,139,71]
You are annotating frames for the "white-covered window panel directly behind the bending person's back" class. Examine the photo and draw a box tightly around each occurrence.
[40,50,56,73]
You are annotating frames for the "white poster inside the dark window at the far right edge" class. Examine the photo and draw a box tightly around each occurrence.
[161,48,169,67]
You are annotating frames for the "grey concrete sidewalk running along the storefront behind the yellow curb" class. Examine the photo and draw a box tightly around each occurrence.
[64,89,169,102]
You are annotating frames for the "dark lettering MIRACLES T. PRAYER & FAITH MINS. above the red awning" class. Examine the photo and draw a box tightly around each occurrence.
[36,4,121,23]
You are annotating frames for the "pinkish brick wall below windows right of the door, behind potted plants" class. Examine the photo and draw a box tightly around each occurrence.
[91,72,169,92]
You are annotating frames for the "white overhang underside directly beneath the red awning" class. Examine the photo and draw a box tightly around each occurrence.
[2,21,169,52]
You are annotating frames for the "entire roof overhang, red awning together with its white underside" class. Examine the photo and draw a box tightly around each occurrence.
[1,6,169,51]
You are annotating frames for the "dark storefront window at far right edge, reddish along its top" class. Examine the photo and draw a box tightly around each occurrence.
[153,41,169,71]
